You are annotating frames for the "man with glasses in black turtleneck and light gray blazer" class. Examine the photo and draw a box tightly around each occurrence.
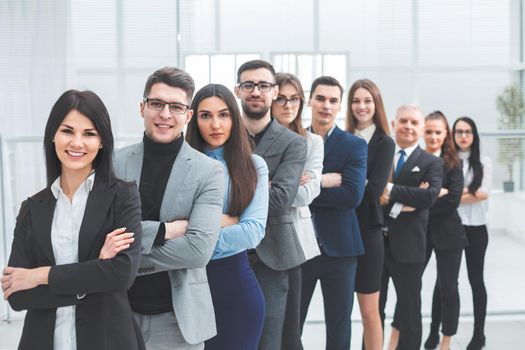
[115,67,224,350]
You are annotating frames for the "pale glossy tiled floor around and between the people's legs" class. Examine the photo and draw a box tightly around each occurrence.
[0,230,525,350]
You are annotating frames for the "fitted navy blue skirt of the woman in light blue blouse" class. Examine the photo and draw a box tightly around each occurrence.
[204,251,265,350]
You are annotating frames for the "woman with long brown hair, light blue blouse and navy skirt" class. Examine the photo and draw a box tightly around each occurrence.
[186,84,269,350]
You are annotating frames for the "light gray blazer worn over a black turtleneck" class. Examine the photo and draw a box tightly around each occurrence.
[115,141,224,344]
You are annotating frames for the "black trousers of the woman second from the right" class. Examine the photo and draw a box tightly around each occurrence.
[425,240,463,336]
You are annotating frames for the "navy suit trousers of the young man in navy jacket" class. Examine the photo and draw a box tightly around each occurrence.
[301,254,357,350]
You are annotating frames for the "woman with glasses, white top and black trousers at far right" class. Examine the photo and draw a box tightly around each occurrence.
[452,117,492,350]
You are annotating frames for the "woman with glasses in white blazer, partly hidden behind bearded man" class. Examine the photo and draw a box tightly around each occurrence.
[272,73,324,350]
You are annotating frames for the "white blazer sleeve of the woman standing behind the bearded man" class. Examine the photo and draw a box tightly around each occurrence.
[292,133,324,207]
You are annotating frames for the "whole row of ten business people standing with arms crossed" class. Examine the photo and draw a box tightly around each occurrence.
[2,60,486,349]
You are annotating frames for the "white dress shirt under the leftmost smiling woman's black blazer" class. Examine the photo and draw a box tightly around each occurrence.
[51,173,95,350]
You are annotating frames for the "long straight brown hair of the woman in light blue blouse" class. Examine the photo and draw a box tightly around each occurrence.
[186,84,257,216]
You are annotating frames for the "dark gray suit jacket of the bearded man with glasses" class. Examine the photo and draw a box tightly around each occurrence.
[255,120,307,271]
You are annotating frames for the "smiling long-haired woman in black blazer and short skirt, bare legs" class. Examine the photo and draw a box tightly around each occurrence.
[346,79,395,350]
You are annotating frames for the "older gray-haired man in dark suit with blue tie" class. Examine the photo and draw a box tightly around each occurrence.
[380,105,443,350]
